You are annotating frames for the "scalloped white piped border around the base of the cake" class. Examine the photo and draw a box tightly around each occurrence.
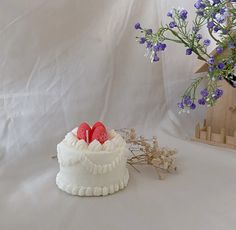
[56,169,129,196]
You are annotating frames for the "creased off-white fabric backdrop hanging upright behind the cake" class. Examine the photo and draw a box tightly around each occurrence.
[0,0,203,162]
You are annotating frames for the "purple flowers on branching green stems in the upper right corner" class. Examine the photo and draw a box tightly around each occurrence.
[135,0,236,112]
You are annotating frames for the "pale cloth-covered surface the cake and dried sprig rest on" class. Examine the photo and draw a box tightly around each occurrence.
[0,130,236,230]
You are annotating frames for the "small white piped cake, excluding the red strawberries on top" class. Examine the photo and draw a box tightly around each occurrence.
[56,129,129,196]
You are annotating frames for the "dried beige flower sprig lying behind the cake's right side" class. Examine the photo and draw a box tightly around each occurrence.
[117,129,177,179]
